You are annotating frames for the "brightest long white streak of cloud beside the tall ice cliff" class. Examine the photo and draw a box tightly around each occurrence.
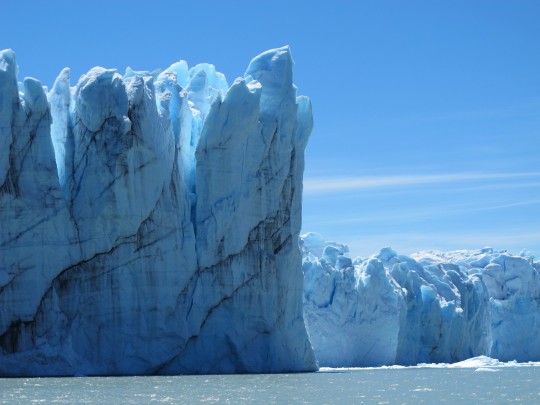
[304,172,540,194]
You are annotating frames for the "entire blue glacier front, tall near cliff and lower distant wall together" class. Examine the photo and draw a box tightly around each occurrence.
[0,47,540,376]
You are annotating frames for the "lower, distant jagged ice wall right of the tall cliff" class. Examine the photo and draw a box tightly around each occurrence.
[300,233,540,367]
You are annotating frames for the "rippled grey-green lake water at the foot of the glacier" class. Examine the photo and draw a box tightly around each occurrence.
[0,366,540,404]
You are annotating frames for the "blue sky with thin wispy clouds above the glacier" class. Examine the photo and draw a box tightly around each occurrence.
[0,0,540,256]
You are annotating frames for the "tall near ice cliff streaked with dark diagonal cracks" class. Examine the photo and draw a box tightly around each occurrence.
[0,47,316,376]
